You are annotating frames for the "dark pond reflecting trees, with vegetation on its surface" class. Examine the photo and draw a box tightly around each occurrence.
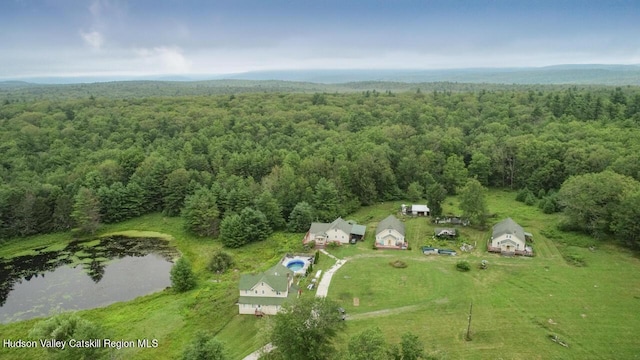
[0,236,178,323]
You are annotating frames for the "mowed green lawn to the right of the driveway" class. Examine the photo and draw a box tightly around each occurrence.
[329,192,640,359]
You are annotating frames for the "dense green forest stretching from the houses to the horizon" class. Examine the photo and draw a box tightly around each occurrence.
[0,83,640,246]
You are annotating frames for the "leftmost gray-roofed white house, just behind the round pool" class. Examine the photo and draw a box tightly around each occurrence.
[302,217,366,247]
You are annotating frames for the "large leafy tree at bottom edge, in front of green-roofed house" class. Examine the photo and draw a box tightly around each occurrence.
[270,297,344,360]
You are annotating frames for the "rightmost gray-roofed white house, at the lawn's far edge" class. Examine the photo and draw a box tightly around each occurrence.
[487,218,533,256]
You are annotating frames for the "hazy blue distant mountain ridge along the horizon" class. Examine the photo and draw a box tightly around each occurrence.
[0,64,640,88]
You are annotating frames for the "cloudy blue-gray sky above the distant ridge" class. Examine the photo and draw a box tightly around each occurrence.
[0,0,640,79]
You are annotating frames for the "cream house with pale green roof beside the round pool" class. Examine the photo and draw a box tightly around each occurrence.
[238,264,298,315]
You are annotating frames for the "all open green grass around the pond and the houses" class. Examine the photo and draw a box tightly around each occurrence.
[0,191,640,359]
